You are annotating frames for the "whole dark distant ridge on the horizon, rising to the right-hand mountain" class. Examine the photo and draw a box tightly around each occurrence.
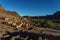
[23,11,60,20]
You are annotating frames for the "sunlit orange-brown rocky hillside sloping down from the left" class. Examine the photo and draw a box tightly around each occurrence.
[0,5,31,29]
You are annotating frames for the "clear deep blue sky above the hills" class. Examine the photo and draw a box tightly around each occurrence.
[0,0,60,16]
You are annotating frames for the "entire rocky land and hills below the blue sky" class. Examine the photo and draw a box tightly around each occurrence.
[0,5,60,40]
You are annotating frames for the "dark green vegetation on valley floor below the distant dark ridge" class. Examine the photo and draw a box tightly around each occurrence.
[25,17,60,30]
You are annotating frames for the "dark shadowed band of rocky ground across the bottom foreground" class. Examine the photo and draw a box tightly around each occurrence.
[0,31,60,40]
